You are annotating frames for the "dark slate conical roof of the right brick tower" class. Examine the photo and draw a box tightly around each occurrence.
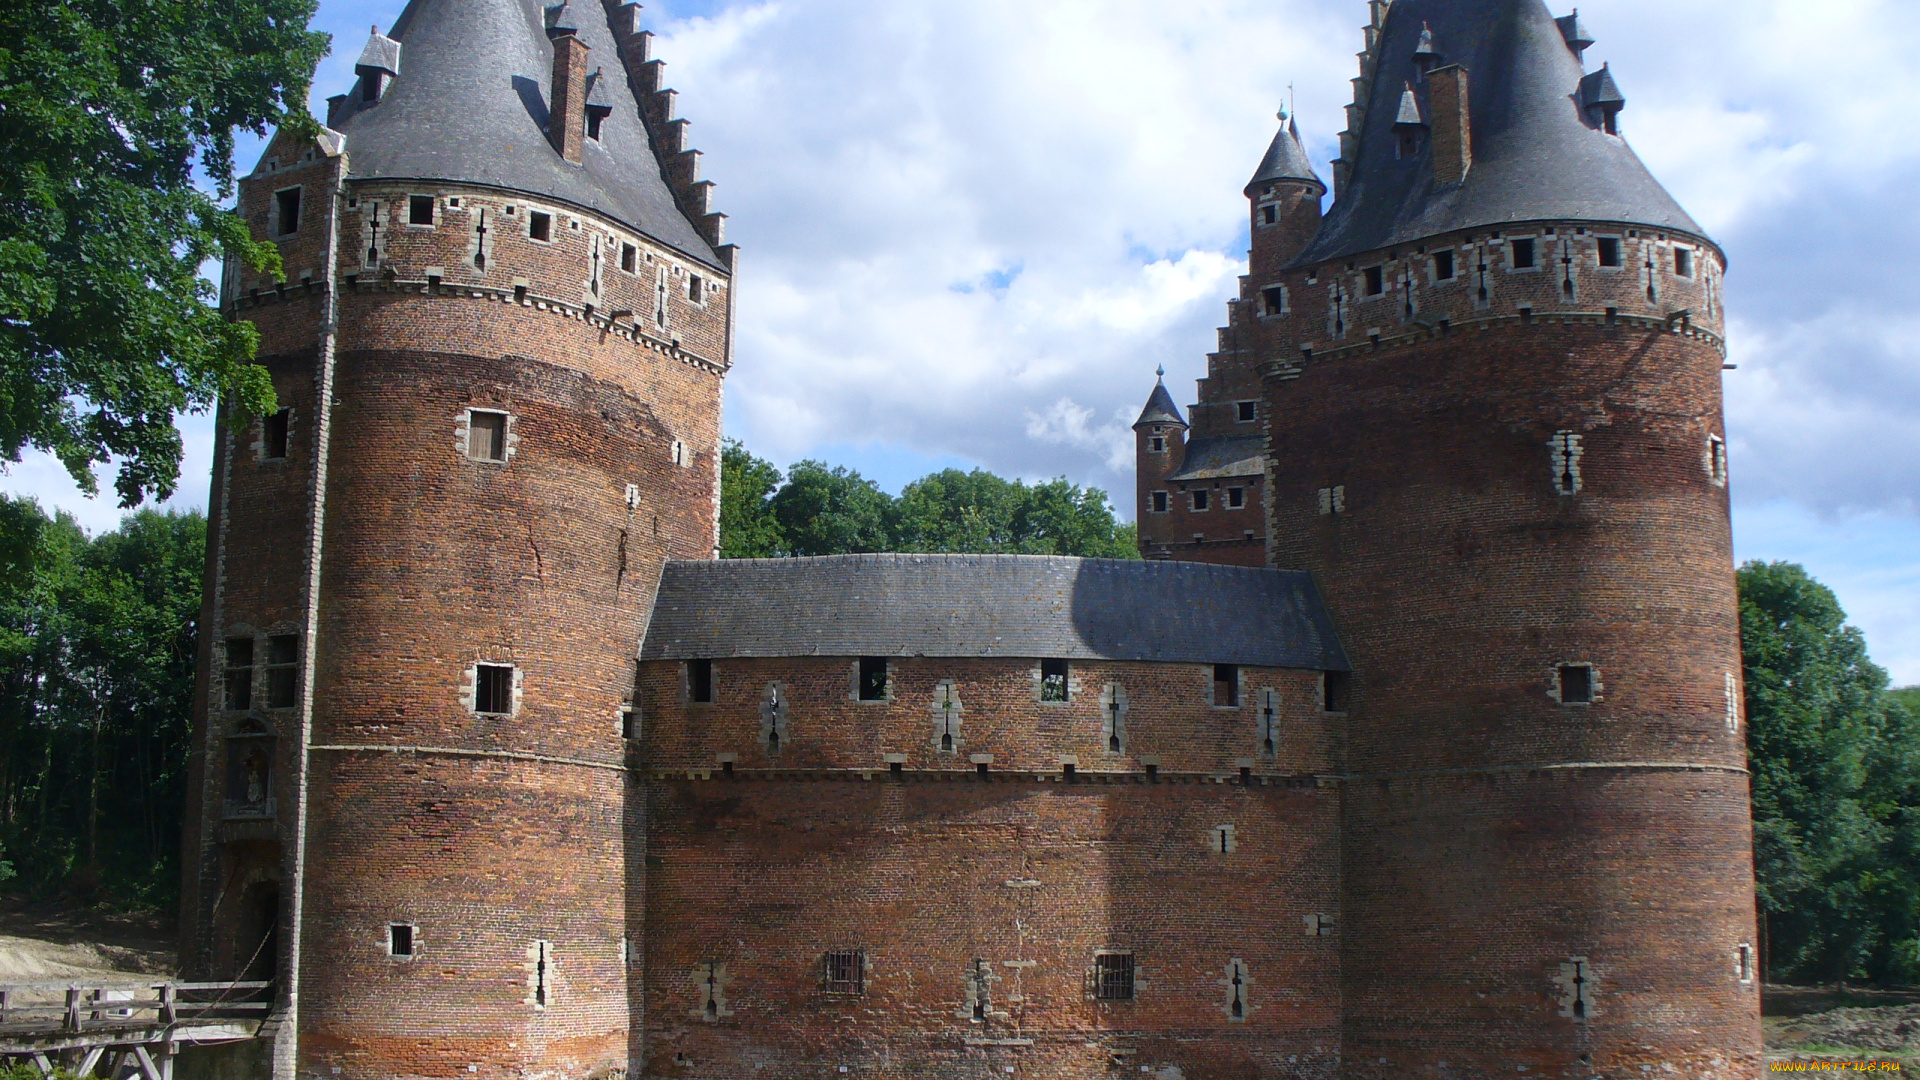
[1294,0,1703,265]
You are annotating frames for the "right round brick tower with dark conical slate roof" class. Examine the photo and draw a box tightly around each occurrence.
[1182,0,1759,1080]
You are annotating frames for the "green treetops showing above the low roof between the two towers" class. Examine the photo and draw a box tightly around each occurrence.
[720,440,1140,559]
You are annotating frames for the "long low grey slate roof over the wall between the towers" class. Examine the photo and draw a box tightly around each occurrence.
[639,555,1348,671]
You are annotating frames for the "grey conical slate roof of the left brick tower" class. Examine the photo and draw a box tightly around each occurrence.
[328,0,720,267]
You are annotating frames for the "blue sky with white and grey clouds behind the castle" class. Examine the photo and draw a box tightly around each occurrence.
[0,0,1920,684]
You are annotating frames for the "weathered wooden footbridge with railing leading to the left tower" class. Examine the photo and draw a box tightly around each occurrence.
[0,982,273,1080]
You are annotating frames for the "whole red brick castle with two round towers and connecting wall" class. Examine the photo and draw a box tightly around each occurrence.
[182,0,1761,1080]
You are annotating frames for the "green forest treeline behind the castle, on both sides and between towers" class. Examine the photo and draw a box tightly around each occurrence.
[0,466,1920,982]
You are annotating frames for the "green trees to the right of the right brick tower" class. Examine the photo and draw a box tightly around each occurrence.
[1740,563,1920,982]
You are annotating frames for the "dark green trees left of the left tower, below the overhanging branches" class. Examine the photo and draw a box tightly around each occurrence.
[0,498,207,905]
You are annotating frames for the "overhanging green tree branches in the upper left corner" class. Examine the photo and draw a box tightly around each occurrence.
[0,0,328,505]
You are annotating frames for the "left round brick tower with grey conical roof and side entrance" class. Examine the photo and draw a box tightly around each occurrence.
[182,0,733,1078]
